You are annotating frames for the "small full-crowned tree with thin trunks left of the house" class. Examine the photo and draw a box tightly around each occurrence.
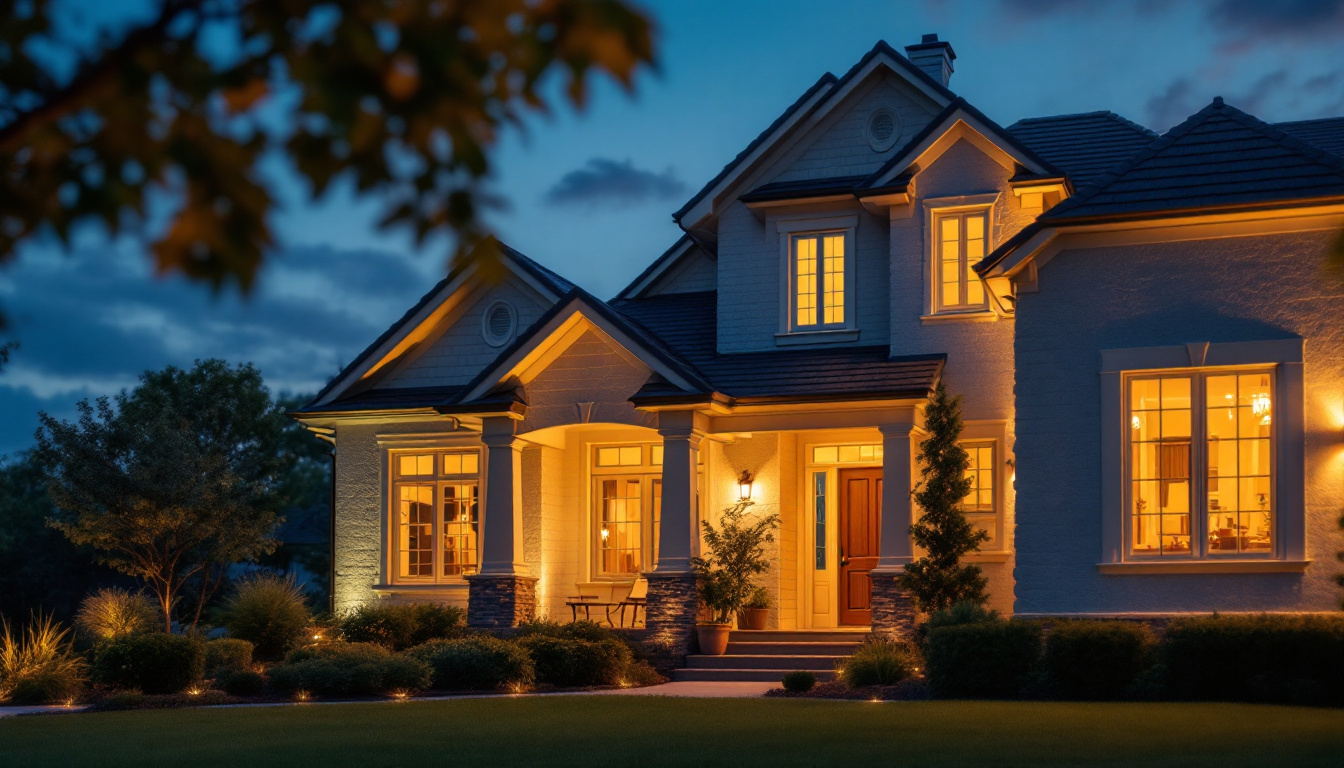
[36,359,292,631]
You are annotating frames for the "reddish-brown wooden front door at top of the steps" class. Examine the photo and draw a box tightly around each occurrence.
[840,469,882,624]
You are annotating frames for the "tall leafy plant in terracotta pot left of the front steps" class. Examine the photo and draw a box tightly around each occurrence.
[691,500,780,656]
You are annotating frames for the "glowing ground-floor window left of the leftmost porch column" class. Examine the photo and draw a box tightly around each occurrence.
[391,451,480,584]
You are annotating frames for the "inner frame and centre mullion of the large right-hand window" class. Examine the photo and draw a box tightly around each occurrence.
[1122,366,1279,560]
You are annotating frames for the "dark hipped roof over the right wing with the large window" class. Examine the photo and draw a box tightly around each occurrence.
[1039,98,1344,223]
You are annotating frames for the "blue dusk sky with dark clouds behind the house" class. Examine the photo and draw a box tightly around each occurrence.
[0,0,1344,455]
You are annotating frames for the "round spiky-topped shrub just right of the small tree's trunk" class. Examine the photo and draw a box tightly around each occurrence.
[220,573,312,660]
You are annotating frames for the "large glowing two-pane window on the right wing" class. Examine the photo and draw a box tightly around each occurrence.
[1125,370,1274,558]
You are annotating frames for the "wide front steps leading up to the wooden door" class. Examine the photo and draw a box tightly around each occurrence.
[672,629,868,683]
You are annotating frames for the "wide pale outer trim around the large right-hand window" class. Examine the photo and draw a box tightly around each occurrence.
[1098,339,1309,574]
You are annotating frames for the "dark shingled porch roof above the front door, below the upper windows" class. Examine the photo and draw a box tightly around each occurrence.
[612,291,946,401]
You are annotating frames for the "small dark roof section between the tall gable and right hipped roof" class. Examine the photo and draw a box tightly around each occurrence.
[1007,112,1157,190]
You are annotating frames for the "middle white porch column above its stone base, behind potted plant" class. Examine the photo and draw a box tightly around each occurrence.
[653,412,704,576]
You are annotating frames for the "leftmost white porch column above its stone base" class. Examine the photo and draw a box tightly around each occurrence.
[480,416,528,576]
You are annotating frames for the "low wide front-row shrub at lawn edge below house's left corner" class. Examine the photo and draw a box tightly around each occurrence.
[269,643,433,695]
